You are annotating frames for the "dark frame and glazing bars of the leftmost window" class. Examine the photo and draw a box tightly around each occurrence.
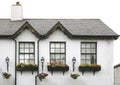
[18,42,35,64]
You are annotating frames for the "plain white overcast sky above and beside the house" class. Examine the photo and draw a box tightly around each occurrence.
[0,0,120,65]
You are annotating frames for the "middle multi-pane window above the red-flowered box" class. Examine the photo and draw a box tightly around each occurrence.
[50,42,66,64]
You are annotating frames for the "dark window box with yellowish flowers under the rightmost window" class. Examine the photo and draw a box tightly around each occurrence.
[79,64,101,74]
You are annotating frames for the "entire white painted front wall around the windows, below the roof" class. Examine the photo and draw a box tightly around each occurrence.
[0,30,113,85]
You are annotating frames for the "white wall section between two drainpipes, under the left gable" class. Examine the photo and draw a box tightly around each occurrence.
[16,29,38,85]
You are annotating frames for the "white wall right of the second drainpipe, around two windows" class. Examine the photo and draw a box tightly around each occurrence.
[38,30,113,85]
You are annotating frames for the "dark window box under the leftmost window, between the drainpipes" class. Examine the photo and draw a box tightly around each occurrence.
[16,63,38,73]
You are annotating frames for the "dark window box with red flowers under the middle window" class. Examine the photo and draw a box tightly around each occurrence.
[47,64,69,74]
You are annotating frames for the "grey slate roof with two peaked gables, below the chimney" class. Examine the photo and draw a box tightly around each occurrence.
[0,19,118,39]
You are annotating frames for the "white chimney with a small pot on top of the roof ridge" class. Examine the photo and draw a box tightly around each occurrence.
[11,2,23,21]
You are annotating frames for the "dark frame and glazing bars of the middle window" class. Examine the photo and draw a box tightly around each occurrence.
[49,41,66,64]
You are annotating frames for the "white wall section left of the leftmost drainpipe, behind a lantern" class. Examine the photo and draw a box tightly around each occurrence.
[0,39,15,85]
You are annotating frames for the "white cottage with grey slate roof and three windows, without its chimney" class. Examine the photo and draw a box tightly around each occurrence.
[0,3,118,85]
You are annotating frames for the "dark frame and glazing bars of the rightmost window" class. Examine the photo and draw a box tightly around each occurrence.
[80,42,97,64]
